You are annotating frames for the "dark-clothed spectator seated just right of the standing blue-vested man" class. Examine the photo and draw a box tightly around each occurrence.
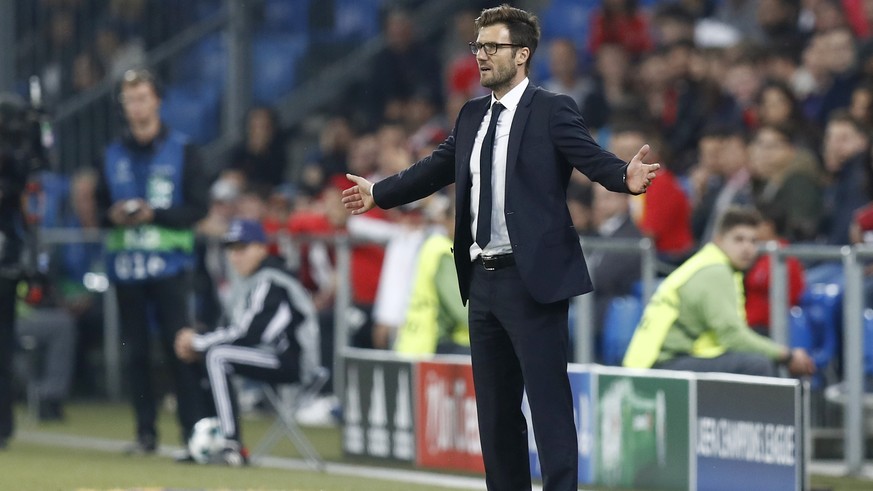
[227,106,288,193]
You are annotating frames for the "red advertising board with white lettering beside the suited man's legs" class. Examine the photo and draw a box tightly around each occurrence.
[416,361,485,473]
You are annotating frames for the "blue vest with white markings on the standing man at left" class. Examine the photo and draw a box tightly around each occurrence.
[103,130,194,282]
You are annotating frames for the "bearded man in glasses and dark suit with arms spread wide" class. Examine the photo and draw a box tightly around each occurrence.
[343,5,658,491]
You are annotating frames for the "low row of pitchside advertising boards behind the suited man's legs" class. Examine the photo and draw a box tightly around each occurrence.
[342,348,809,491]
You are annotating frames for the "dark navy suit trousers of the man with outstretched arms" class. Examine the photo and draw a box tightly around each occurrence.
[469,262,578,491]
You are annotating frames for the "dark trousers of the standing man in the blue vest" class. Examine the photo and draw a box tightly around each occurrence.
[115,273,214,442]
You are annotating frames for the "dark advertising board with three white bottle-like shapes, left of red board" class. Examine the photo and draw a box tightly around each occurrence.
[343,355,415,462]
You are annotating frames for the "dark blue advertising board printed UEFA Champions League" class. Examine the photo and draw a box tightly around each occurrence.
[695,375,803,491]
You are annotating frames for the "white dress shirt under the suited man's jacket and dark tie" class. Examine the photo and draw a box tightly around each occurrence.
[470,78,529,261]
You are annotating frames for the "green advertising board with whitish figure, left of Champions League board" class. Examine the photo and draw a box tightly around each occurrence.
[595,371,692,490]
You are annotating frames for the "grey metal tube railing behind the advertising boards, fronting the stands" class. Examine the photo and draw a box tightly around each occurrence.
[34,229,873,475]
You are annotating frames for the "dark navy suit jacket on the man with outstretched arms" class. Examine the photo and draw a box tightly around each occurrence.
[373,85,628,303]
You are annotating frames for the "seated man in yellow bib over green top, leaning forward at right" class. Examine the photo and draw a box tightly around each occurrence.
[623,207,815,377]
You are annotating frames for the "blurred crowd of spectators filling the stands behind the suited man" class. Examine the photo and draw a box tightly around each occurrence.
[15,0,873,410]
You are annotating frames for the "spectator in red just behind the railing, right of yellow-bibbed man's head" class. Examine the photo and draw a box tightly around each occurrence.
[743,208,804,336]
